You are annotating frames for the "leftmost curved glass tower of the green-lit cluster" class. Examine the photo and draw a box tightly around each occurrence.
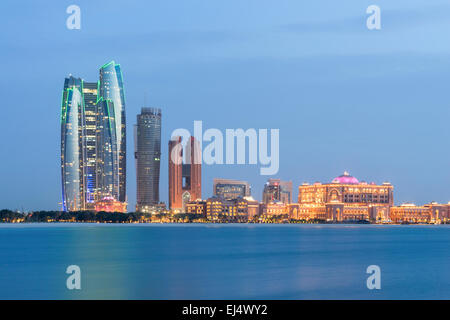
[61,76,84,211]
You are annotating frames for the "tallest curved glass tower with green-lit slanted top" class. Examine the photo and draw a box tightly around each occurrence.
[97,61,127,202]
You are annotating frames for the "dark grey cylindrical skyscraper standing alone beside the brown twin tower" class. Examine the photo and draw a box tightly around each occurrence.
[135,108,161,212]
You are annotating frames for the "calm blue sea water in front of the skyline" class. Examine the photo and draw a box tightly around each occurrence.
[0,224,450,299]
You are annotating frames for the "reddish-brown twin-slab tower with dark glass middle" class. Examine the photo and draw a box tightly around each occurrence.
[169,137,202,210]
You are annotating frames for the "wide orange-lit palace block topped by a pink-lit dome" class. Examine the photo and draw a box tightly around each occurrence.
[297,172,394,221]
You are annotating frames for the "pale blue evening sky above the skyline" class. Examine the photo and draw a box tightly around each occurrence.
[0,0,450,210]
